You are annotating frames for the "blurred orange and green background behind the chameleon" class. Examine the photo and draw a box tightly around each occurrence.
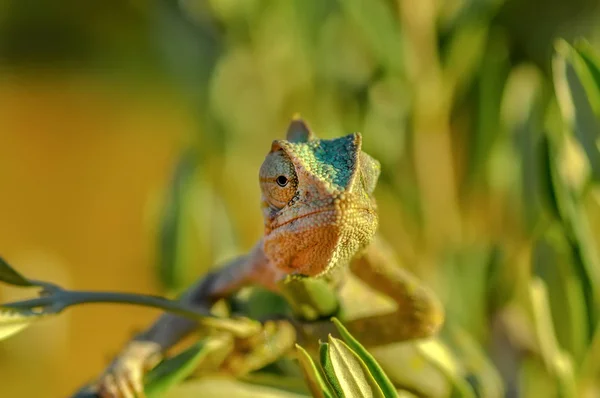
[0,0,600,397]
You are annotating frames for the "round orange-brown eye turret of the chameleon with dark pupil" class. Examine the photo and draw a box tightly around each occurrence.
[259,151,298,209]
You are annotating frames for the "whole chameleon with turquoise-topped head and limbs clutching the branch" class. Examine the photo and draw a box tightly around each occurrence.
[96,117,444,398]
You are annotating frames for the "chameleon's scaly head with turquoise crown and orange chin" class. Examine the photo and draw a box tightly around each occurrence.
[259,118,380,277]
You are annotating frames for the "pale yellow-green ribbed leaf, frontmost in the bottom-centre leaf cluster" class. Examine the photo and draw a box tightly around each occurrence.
[329,335,386,397]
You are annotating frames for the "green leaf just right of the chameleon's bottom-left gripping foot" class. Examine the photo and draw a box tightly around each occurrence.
[144,338,226,398]
